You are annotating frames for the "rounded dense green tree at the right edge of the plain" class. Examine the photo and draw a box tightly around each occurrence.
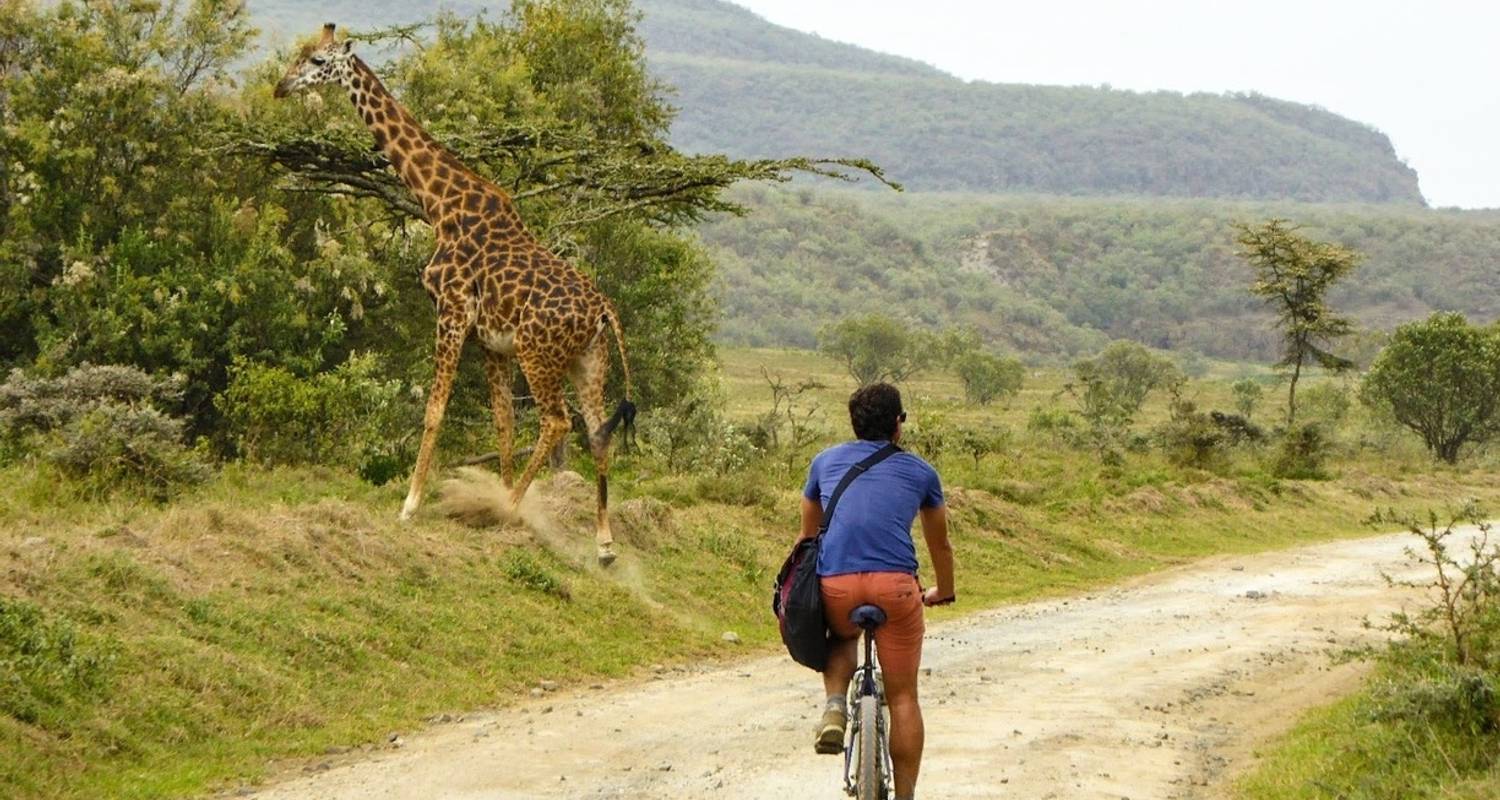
[1361,314,1500,464]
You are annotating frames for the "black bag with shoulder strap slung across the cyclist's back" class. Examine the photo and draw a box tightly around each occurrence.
[771,444,902,672]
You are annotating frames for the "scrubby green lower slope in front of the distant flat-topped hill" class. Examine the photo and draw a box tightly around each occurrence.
[701,188,1500,359]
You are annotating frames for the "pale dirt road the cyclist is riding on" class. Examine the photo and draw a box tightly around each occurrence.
[255,536,1440,800]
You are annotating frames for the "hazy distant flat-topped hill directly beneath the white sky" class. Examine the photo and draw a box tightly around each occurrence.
[251,0,1422,206]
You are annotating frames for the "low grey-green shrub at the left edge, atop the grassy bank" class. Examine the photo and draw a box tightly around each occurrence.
[0,365,210,498]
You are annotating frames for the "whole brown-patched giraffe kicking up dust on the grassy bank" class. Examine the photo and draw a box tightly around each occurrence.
[275,23,636,566]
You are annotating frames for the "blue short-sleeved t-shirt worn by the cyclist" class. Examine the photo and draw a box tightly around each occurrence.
[803,440,942,576]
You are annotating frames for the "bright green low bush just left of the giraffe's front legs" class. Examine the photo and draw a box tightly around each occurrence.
[216,354,420,483]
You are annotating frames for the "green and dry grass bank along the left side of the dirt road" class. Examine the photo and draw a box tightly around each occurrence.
[0,351,1500,798]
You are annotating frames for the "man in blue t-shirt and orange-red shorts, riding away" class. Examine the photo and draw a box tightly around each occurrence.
[801,383,954,800]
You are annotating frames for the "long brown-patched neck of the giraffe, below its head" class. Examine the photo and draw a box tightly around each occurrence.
[345,56,519,222]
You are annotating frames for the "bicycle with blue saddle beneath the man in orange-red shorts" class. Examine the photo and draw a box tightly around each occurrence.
[845,605,894,800]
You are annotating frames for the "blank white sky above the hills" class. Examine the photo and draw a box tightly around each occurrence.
[734,0,1500,209]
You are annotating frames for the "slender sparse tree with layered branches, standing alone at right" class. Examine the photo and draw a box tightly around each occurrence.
[1236,219,1361,428]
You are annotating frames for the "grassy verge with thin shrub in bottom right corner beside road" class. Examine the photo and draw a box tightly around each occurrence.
[1238,512,1500,800]
